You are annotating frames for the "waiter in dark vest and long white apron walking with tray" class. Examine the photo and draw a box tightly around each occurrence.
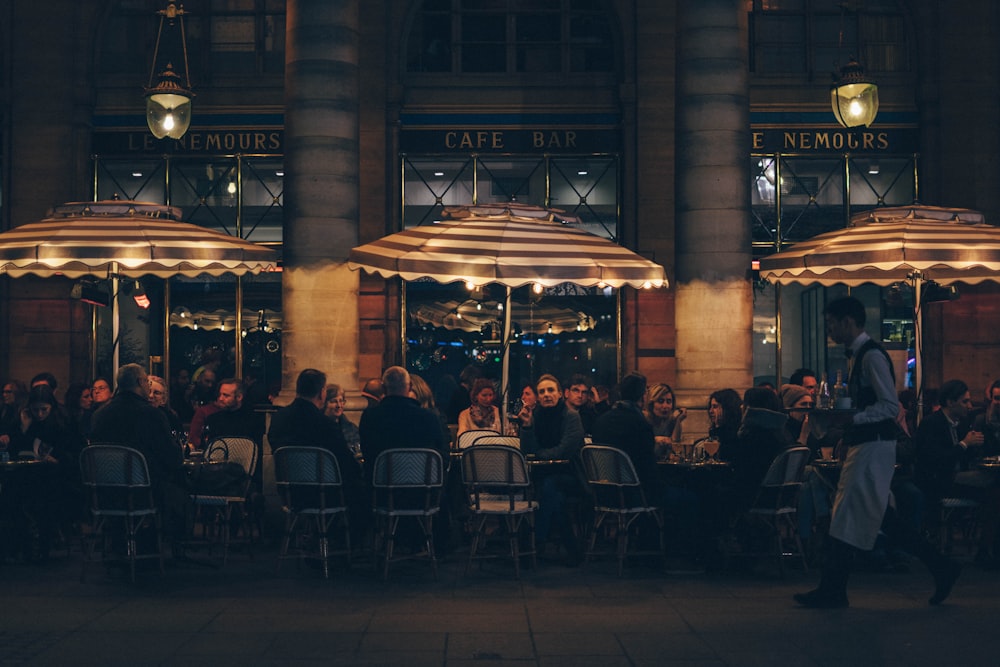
[794,297,961,609]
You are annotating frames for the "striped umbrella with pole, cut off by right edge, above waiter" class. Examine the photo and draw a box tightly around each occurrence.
[760,205,1000,410]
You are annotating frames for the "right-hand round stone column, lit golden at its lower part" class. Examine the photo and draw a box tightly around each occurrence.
[676,0,753,426]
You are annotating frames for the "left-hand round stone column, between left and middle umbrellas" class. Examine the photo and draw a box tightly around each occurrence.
[280,0,360,396]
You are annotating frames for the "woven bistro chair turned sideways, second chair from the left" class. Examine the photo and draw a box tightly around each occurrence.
[191,436,260,564]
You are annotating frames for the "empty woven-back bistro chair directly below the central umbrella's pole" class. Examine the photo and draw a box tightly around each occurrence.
[462,444,538,578]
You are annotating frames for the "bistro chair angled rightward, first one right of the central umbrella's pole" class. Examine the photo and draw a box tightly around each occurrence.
[581,445,666,577]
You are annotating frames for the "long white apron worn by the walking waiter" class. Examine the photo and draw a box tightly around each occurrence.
[830,440,896,551]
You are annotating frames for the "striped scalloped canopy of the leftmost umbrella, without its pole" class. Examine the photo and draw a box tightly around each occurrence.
[0,200,277,278]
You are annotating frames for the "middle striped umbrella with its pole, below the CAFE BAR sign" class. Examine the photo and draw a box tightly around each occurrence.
[348,203,667,410]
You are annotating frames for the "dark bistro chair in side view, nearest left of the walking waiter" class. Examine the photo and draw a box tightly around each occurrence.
[743,447,810,577]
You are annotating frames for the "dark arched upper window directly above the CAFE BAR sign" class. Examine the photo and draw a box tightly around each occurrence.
[406,0,615,74]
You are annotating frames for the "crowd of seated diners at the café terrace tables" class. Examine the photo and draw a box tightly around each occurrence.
[0,359,1000,568]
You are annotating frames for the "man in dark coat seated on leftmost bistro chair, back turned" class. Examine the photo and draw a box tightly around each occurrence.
[90,364,188,538]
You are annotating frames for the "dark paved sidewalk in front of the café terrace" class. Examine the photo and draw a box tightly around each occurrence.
[0,550,1000,667]
